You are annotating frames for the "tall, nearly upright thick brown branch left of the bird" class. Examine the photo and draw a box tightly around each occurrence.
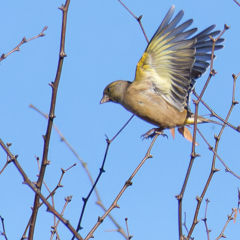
[28,0,70,240]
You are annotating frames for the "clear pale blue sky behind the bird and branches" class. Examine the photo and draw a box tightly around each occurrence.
[0,0,240,240]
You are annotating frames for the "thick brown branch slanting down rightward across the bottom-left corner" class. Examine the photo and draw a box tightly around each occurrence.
[0,139,82,240]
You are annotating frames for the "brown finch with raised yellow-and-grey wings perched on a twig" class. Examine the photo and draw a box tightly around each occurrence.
[100,5,225,141]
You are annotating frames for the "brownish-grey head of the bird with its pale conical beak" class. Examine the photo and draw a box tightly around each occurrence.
[100,80,131,104]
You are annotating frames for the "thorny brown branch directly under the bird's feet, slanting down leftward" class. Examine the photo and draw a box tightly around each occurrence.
[85,133,160,240]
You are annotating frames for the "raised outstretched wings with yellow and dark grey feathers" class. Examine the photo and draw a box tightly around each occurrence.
[135,5,223,111]
